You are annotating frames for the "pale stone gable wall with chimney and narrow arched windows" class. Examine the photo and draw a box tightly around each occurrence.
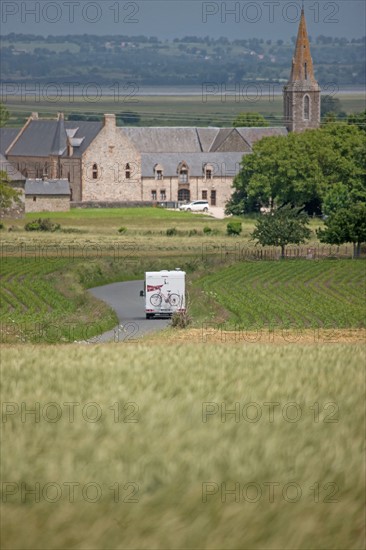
[81,115,144,202]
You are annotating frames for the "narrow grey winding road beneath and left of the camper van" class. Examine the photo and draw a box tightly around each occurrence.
[89,281,170,342]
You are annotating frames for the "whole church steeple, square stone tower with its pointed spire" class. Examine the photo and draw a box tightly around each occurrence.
[283,8,320,132]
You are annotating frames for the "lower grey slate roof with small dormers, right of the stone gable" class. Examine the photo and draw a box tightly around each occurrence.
[141,153,243,178]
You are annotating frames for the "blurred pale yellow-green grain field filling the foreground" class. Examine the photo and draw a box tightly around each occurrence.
[1,344,365,550]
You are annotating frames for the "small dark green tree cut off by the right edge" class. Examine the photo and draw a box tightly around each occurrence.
[317,202,366,258]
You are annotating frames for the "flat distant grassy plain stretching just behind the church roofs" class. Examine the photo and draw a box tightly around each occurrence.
[6,94,365,127]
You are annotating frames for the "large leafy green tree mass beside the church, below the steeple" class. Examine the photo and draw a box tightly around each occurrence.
[226,124,366,215]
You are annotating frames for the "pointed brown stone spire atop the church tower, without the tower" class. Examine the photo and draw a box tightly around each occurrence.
[290,7,316,83]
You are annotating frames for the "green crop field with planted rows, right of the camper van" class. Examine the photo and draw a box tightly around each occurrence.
[195,260,366,330]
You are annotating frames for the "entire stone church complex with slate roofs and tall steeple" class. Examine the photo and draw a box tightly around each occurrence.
[0,10,320,211]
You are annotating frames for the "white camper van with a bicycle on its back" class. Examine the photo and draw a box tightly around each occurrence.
[140,269,186,319]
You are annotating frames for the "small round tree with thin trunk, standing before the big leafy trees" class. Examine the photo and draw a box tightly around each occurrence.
[251,204,311,258]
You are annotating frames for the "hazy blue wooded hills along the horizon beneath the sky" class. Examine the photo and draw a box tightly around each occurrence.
[0,33,365,86]
